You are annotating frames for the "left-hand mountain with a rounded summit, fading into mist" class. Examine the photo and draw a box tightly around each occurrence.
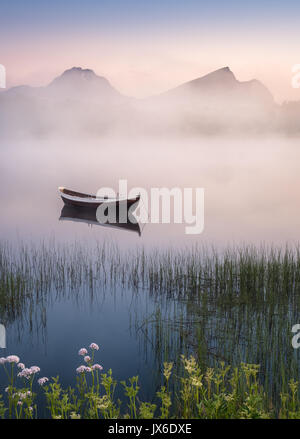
[0,67,130,135]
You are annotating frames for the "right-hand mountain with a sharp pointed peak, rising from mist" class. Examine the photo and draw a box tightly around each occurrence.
[142,67,277,133]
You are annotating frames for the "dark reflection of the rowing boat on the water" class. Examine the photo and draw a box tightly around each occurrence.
[59,205,141,236]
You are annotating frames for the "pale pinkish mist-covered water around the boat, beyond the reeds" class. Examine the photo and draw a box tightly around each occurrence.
[0,137,300,247]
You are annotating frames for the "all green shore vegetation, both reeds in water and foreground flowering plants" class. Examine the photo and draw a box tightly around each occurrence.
[0,242,300,418]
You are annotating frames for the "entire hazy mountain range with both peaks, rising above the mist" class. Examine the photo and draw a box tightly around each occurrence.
[0,67,300,136]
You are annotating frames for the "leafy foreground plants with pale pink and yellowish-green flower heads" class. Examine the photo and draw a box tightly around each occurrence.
[0,343,300,419]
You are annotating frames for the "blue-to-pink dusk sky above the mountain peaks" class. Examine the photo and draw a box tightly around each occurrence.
[0,0,300,102]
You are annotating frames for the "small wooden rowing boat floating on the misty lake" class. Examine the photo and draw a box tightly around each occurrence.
[58,187,140,209]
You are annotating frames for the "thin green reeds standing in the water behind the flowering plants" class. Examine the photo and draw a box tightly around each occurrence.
[0,242,300,406]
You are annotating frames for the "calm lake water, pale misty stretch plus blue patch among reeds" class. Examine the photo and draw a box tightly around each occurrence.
[0,138,300,412]
